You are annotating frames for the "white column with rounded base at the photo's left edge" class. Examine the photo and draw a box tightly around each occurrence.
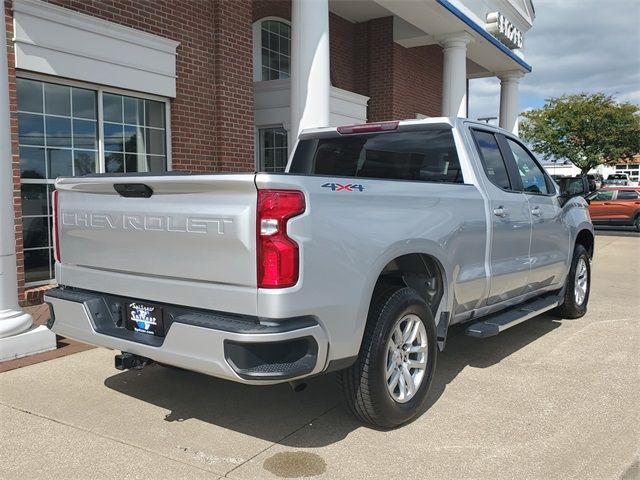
[0,9,56,361]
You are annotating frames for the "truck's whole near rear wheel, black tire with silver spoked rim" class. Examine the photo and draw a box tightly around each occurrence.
[338,287,437,428]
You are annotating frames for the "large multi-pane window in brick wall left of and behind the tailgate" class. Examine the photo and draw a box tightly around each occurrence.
[17,78,167,286]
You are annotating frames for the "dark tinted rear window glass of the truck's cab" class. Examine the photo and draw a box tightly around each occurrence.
[289,129,463,183]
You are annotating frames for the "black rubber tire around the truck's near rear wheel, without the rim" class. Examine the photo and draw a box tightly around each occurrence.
[338,286,437,428]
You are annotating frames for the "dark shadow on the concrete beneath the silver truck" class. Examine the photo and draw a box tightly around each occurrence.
[104,315,562,448]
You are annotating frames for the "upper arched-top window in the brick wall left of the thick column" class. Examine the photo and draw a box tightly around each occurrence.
[260,20,291,80]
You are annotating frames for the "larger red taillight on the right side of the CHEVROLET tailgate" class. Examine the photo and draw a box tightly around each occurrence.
[256,190,305,288]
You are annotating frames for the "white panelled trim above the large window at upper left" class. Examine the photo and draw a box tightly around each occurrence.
[13,0,179,98]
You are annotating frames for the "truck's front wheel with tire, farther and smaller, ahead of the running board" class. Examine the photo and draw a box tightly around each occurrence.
[556,244,591,318]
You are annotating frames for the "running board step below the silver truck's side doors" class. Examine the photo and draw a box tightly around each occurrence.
[464,295,561,338]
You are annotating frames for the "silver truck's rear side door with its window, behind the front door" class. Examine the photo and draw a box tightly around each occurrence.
[472,129,531,305]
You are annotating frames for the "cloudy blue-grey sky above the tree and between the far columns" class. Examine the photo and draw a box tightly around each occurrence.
[469,0,640,118]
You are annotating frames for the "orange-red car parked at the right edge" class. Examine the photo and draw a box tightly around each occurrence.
[587,187,640,232]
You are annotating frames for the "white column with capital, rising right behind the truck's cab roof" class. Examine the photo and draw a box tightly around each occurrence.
[438,32,473,117]
